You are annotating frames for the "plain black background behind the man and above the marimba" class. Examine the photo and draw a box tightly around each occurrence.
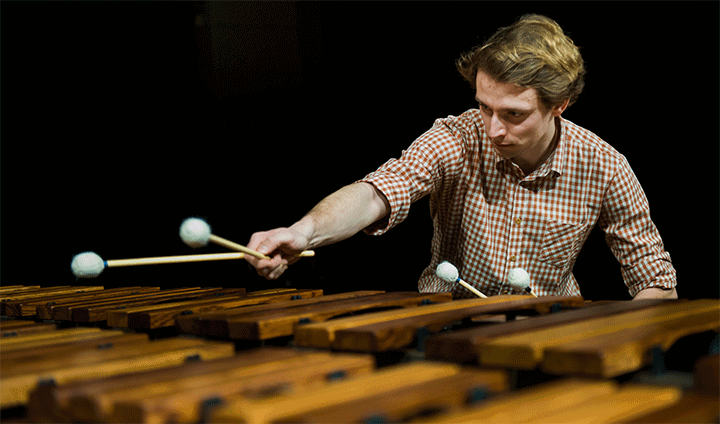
[0,2,720,299]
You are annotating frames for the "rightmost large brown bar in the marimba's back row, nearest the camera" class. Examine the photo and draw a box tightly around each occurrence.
[541,310,720,378]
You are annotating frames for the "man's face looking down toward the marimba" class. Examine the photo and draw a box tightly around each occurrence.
[475,71,567,169]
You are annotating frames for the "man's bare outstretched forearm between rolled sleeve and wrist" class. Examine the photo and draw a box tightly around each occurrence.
[290,182,390,249]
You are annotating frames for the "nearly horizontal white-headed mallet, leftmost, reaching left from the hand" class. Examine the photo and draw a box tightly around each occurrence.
[70,252,245,278]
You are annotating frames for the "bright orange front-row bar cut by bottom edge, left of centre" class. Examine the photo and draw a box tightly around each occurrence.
[211,361,462,424]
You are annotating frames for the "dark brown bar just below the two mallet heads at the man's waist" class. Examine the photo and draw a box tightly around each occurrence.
[332,296,584,352]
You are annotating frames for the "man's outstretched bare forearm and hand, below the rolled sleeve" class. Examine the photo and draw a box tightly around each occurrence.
[246,182,390,280]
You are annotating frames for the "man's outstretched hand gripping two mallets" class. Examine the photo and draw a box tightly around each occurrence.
[245,228,308,280]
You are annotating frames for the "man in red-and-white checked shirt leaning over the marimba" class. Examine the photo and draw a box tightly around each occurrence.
[248,15,677,299]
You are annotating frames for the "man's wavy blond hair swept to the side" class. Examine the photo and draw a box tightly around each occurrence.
[456,15,585,108]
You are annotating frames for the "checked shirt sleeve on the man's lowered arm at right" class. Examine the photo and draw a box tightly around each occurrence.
[599,157,677,297]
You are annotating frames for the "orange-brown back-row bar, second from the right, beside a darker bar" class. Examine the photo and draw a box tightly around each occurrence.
[476,299,720,369]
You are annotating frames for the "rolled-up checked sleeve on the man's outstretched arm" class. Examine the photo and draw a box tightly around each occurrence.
[360,118,468,235]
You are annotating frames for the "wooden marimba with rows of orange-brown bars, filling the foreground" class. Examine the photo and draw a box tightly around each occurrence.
[0,286,720,423]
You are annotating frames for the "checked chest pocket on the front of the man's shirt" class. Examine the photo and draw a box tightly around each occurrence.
[539,221,586,268]
